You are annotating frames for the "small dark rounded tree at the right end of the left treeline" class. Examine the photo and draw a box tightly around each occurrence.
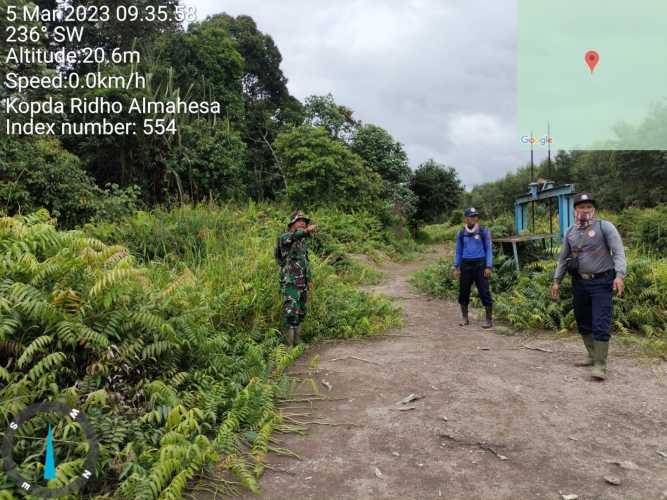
[410,160,463,223]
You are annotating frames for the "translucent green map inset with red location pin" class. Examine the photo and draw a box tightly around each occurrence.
[517,0,667,150]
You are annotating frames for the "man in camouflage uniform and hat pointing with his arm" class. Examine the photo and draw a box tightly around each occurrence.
[275,210,317,346]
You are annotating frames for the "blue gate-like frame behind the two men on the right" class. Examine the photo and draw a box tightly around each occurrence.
[514,181,576,239]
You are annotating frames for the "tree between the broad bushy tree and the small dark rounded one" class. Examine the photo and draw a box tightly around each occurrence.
[351,123,410,184]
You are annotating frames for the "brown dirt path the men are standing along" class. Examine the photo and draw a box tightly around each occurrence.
[241,247,667,500]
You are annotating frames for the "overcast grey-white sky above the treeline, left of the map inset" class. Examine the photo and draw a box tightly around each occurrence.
[186,0,544,188]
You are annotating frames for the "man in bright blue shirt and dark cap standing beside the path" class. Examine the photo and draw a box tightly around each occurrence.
[452,208,493,328]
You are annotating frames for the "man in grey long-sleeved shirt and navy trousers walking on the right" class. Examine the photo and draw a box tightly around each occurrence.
[551,193,627,380]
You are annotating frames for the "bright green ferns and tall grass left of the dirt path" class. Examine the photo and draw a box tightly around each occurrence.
[0,205,400,498]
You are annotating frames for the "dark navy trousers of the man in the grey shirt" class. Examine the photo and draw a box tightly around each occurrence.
[572,270,614,342]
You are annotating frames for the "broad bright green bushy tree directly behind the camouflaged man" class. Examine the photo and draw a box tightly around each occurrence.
[274,125,382,210]
